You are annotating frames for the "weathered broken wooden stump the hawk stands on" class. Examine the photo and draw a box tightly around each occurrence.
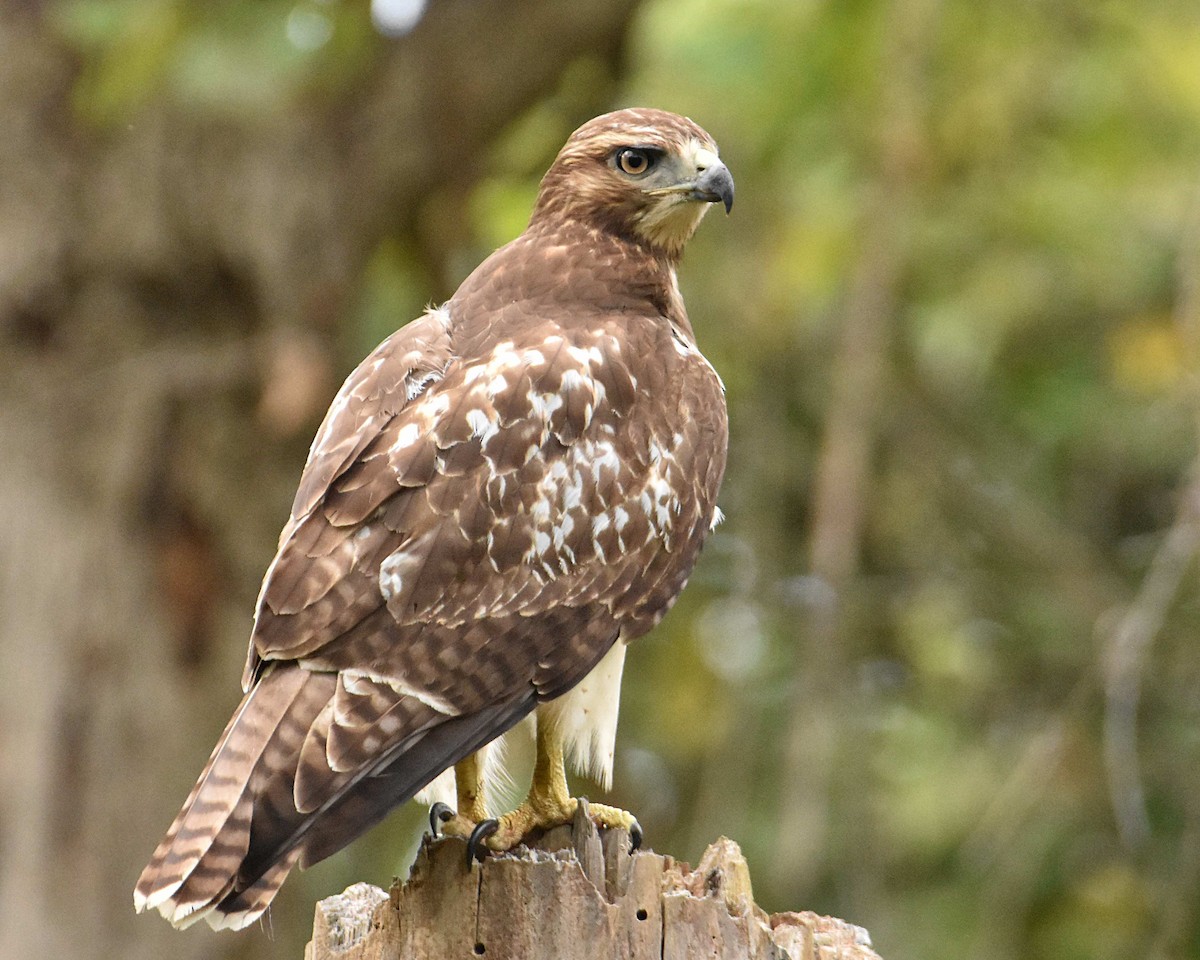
[305,805,880,960]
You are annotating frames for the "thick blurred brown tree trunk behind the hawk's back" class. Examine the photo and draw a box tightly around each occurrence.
[0,0,636,960]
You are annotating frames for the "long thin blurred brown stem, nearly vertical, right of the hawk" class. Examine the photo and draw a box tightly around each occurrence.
[775,0,938,889]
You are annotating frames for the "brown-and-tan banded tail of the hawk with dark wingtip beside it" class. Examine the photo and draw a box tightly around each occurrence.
[134,664,535,929]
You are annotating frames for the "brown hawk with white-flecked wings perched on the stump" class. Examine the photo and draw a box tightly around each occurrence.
[134,109,733,929]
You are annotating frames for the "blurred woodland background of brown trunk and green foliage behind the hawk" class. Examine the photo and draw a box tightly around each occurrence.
[0,0,1200,960]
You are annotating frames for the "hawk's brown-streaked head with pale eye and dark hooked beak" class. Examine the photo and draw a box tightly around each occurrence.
[532,109,733,259]
